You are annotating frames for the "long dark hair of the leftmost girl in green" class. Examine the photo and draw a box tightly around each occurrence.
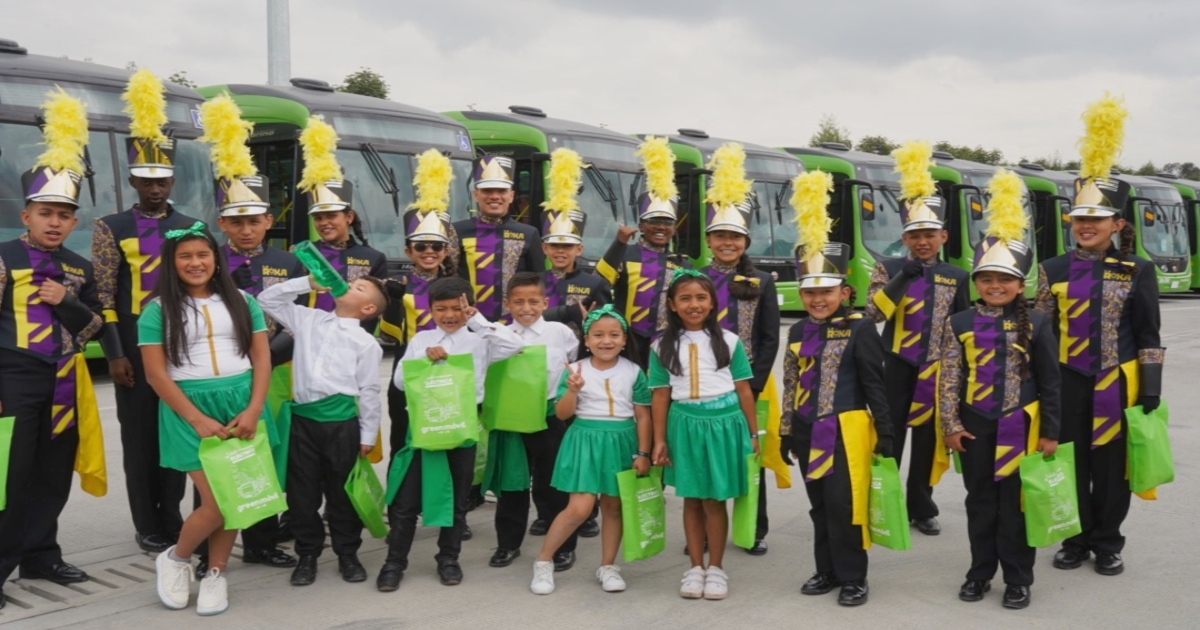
[150,228,253,367]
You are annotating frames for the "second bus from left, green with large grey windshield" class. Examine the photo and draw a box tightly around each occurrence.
[199,78,475,271]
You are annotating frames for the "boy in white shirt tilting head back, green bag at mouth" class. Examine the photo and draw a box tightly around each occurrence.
[258,276,388,587]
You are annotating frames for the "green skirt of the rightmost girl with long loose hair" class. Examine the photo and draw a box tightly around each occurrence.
[666,392,754,500]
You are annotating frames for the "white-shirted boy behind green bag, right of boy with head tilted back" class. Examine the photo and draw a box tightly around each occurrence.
[376,277,524,592]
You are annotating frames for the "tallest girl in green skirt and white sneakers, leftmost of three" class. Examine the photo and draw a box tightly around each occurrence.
[138,222,271,614]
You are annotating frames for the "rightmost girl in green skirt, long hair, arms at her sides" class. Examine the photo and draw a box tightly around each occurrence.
[649,269,758,600]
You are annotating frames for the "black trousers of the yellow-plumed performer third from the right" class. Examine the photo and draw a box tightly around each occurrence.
[883,353,940,520]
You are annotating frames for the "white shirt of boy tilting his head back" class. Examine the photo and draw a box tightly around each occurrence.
[258,276,383,446]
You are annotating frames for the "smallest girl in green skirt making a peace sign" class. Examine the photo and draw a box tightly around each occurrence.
[529,305,652,595]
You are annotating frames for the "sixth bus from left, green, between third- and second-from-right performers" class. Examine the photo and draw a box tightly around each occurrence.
[930,151,1038,299]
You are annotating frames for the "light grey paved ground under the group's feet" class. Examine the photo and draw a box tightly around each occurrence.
[0,295,1200,630]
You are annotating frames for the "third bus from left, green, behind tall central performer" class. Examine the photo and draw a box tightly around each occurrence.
[445,106,648,268]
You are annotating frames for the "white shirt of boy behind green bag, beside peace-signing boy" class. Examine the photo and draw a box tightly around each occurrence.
[392,312,524,404]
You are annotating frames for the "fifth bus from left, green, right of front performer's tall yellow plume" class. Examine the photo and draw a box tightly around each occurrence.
[784,143,908,306]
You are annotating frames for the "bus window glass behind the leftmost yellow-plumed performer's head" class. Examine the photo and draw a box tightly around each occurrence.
[0,122,123,258]
